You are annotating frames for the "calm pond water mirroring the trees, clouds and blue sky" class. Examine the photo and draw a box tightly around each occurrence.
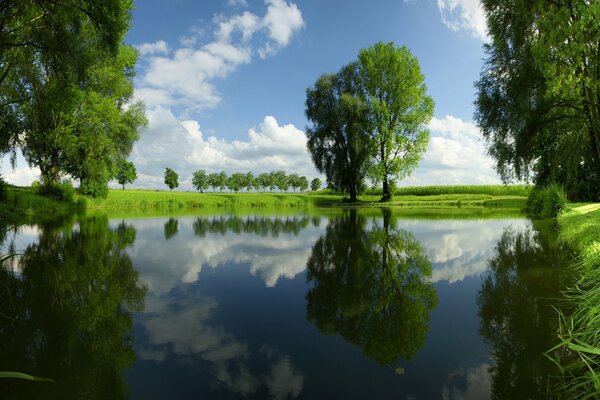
[0,210,570,399]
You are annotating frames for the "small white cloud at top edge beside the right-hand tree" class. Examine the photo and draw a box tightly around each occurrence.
[437,0,488,41]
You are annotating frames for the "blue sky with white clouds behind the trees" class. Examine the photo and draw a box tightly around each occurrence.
[1,0,500,190]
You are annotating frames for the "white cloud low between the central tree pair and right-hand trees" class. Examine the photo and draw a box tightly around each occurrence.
[400,115,501,186]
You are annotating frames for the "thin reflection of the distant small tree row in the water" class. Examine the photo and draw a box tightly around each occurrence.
[193,215,310,237]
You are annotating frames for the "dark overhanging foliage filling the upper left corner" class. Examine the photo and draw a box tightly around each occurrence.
[0,0,133,158]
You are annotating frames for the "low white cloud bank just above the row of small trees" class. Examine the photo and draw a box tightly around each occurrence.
[130,107,320,190]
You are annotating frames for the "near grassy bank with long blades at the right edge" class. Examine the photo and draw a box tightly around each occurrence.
[552,204,600,399]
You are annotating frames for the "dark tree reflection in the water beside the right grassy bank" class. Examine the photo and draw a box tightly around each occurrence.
[478,222,571,399]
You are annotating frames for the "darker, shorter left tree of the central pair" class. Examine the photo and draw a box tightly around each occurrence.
[306,63,371,201]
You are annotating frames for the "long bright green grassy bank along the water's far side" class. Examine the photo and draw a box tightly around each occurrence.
[0,186,526,224]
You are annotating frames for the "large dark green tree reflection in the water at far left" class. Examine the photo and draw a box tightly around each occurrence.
[0,216,146,399]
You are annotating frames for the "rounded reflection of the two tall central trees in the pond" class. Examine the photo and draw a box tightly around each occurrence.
[306,210,437,366]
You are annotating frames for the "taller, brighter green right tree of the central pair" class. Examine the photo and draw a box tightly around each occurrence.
[358,42,434,201]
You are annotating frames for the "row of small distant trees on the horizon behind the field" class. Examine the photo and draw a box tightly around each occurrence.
[165,168,321,193]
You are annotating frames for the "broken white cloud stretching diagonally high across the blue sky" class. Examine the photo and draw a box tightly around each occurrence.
[136,0,304,111]
